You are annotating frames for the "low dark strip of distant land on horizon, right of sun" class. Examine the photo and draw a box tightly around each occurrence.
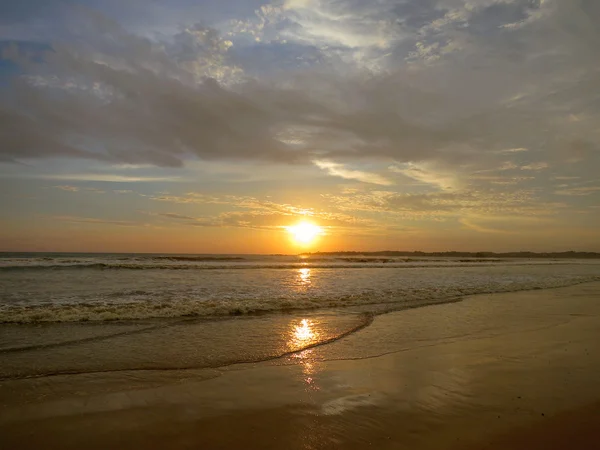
[301,250,600,259]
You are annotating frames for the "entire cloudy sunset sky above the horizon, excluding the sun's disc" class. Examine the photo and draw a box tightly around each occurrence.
[0,0,600,253]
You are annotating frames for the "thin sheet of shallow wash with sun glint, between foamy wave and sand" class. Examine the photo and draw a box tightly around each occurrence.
[0,313,371,379]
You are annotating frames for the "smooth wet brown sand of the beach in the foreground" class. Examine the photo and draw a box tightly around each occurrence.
[0,283,600,450]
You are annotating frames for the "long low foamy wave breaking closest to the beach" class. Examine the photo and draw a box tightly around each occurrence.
[0,276,600,324]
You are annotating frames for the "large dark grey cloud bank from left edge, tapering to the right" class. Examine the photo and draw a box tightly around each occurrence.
[0,14,460,166]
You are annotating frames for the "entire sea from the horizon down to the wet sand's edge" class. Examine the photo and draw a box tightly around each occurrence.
[0,253,600,380]
